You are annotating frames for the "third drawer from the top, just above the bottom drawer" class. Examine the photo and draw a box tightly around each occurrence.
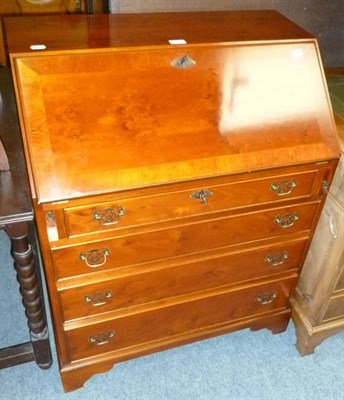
[60,239,307,321]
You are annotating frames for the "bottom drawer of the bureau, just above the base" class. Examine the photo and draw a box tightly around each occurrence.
[66,277,296,361]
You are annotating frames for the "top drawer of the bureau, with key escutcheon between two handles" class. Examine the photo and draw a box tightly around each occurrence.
[60,165,326,237]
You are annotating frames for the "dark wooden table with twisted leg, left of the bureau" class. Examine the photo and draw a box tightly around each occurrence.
[0,68,52,369]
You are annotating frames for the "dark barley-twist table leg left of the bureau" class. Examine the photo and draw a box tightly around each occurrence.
[5,222,52,369]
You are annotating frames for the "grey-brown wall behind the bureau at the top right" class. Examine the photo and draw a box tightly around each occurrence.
[110,0,344,67]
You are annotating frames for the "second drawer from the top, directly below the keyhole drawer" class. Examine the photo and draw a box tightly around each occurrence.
[53,203,318,279]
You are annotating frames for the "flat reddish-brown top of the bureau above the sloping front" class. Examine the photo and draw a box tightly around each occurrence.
[5,10,312,54]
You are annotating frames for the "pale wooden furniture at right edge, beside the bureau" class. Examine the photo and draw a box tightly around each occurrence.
[291,70,344,355]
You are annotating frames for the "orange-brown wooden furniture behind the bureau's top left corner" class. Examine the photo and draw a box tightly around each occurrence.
[0,0,110,66]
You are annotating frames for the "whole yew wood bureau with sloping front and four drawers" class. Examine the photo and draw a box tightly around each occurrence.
[5,11,340,391]
